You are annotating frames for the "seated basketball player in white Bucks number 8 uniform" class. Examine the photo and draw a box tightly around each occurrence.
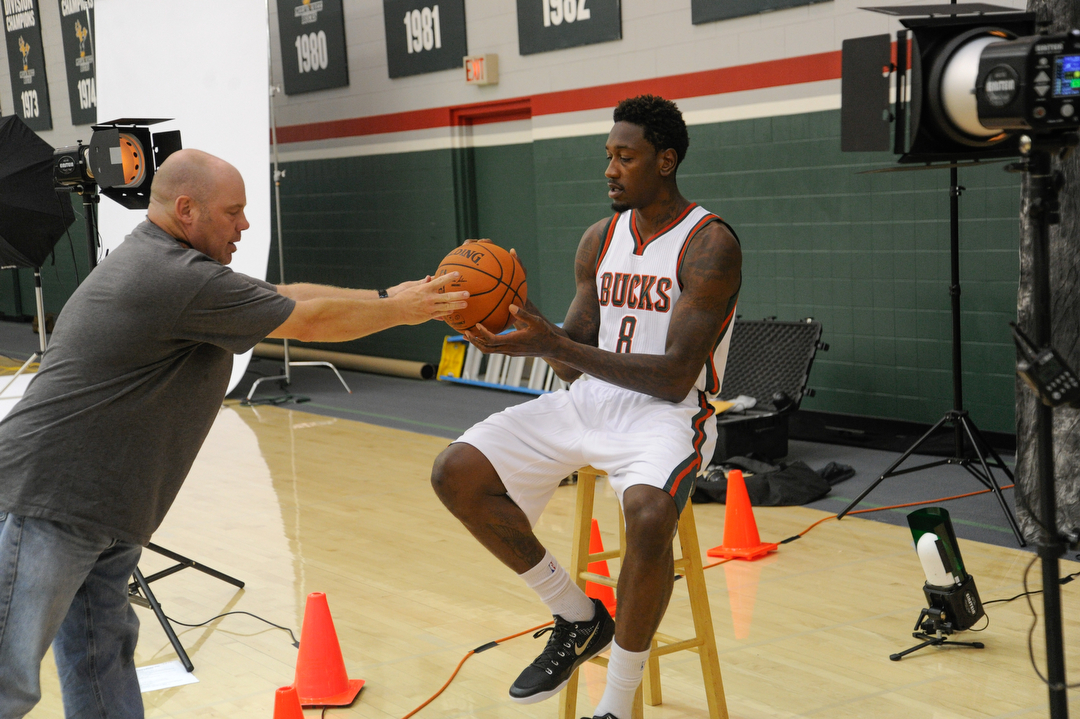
[432,95,742,719]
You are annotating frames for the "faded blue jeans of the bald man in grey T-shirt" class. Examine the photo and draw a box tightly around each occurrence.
[0,512,143,719]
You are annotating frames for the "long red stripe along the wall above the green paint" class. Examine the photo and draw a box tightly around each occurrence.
[278,50,840,144]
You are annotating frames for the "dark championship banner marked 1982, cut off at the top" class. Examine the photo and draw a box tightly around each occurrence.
[517,0,622,55]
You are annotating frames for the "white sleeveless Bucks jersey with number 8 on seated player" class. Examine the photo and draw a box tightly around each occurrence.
[596,203,734,395]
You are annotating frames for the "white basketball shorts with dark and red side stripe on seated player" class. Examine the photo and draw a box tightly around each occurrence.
[457,378,716,526]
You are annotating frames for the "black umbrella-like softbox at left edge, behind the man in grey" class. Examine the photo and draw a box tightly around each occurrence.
[0,116,75,268]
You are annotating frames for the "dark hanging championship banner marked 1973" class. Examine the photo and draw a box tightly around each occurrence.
[3,0,53,130]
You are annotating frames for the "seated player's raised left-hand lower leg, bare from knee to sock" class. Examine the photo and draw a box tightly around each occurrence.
[431,436,545,574]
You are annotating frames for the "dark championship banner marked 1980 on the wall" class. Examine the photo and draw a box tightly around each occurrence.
[278,0,349,95]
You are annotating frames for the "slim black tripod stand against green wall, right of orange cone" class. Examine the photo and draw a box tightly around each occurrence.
[836,166,1023,546]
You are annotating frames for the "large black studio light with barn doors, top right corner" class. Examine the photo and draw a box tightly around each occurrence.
[840,3,1080,163]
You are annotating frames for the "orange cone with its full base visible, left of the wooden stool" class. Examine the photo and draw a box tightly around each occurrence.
[294,592,364,706]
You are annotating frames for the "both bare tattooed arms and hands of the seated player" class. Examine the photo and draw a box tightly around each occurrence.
[469,222,742,402]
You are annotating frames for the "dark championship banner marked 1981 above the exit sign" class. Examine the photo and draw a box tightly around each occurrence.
[382,0,469,78]
